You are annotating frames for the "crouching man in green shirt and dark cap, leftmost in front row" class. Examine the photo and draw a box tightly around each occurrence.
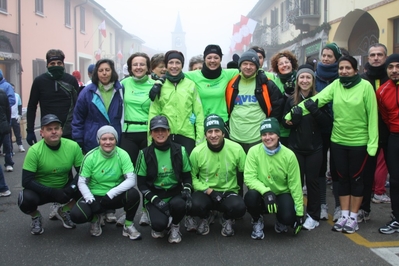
[18,114,83,235]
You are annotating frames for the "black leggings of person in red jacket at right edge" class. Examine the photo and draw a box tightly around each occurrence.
[385,134,399,221]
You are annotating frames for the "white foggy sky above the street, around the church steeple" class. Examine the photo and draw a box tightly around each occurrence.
[96,0,258,60]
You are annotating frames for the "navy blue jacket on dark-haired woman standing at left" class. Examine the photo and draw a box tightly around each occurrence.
[72,81,123,153]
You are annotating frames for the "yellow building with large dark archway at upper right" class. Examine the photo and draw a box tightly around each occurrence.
[328,0,399,67]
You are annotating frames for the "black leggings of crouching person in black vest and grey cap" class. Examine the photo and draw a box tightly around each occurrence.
[145,194,186,232]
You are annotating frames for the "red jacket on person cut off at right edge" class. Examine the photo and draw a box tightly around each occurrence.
[377,79,399,133]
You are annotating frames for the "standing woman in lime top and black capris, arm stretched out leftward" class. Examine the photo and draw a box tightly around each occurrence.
[285,56,378,234]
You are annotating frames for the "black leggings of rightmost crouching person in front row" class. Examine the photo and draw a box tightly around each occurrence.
[244,189,296,225]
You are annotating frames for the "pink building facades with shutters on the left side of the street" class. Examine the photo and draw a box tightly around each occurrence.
[0,0,143,106]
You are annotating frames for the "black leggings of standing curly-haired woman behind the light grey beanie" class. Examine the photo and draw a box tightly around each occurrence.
[121,132,148,166]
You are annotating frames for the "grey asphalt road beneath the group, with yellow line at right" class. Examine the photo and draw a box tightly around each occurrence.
[0,138,399,266]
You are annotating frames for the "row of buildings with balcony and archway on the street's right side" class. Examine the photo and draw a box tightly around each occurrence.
[248,0,399,71]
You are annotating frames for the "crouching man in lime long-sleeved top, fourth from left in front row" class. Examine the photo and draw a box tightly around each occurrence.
[190,114,246,236]
